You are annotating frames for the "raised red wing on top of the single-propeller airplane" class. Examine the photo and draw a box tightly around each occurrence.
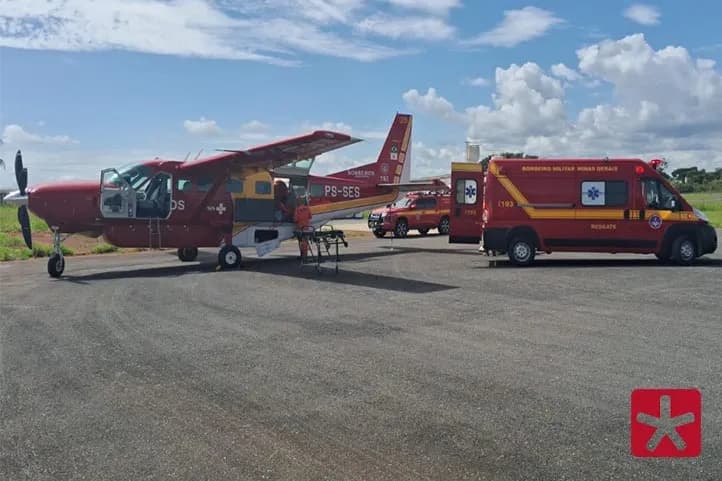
[183,130,361,169]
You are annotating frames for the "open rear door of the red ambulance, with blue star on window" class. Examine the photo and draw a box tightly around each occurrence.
[449,162,484,244]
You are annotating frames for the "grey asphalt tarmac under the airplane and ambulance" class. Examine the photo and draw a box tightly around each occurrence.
[0,237,722,481]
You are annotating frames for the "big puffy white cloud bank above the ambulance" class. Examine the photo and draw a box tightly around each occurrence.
[402,34,722,168]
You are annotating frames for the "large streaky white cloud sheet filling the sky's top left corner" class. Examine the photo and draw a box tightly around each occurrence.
[0,0,405,65]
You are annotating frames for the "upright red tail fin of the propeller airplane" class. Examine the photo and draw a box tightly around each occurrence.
[331,114,413,185]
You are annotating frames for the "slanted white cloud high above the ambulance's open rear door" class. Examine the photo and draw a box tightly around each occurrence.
[465,7,564,47]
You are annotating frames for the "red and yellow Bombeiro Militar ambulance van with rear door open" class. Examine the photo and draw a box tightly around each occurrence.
[449,159,717,266]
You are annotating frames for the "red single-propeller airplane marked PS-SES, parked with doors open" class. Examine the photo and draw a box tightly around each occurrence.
[4,114,423,277]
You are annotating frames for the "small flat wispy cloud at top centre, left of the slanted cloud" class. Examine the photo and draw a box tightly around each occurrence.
[357,15,454,40]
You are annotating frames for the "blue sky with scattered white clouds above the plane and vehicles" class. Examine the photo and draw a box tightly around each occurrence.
[0,0,722,186]
